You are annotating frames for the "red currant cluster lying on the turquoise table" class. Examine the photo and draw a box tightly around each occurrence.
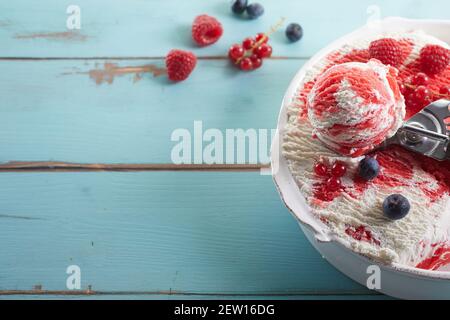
[228,33,272,71]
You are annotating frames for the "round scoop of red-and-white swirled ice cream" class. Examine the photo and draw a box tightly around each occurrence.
[307,60,405,157]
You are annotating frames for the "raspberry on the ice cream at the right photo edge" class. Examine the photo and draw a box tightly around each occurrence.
[419,44,450,75]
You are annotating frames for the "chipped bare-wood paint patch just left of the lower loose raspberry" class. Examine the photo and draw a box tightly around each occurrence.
[67,62,166,85]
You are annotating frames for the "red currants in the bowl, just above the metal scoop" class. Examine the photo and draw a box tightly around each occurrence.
[400,72,450,108]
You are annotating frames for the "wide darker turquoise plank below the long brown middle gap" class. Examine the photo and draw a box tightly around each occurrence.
[0,172,373,296]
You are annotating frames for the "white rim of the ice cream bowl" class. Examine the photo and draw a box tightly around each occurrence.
[271,17,450,280]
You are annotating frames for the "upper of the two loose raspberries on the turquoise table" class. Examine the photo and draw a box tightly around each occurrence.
[192,14,223,47]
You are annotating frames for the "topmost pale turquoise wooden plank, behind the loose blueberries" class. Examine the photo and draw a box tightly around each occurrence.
[0,0,450,57]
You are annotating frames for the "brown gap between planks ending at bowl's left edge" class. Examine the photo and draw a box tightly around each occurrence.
[0,161,270,172]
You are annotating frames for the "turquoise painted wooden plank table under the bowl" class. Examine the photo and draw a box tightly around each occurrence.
[0,0,450,299]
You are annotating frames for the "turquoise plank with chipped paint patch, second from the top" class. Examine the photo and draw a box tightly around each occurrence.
[0,59,304,164]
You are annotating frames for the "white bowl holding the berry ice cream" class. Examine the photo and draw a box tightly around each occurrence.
[271,17,450,299]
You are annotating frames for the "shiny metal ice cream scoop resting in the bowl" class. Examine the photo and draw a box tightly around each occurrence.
[383,99,450,161]
